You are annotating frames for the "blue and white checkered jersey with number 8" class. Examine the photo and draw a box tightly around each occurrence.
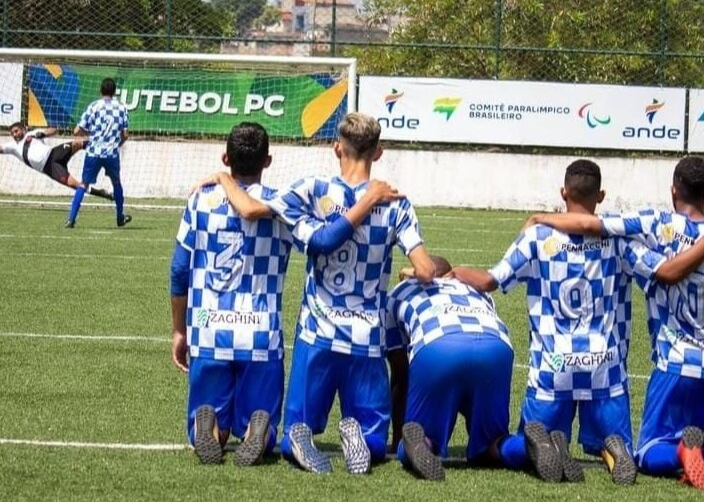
[268,177,423,357]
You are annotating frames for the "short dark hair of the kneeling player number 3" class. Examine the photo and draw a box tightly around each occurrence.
[227,122,269,176]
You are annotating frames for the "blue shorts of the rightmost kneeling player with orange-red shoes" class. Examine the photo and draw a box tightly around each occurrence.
[636,368,704,465]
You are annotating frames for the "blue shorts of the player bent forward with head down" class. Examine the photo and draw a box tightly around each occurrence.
[405,333,513,460]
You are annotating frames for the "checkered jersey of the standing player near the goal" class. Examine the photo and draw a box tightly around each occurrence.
[78,98,129,158]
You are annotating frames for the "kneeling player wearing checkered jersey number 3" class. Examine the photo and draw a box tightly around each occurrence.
[171,123,408,465]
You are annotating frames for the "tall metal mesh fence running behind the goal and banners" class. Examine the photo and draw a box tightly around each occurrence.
[0,0,704,87]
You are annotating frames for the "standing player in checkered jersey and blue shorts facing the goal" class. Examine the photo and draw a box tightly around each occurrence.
[66,78,132,228]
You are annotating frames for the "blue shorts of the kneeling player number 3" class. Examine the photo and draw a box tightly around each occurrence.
[187,357,284,443]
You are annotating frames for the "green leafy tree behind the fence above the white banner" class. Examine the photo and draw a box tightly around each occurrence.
[347,0,704,85]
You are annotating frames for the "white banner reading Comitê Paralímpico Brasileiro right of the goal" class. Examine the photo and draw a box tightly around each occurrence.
[359,77,686,151]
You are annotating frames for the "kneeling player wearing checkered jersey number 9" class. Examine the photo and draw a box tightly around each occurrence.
[455,160,696,484]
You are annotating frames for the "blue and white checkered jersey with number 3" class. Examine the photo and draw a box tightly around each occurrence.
[176,184,292,361]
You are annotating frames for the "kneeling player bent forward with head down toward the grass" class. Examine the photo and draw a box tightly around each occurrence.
[386,256,513,480]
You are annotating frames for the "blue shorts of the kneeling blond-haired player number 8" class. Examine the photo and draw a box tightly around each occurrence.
[282,338,391,453]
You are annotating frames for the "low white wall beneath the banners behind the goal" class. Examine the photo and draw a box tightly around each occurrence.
[0,138,677,211]
